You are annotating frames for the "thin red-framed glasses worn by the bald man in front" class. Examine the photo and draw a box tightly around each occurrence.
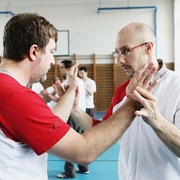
[112,42,148,57]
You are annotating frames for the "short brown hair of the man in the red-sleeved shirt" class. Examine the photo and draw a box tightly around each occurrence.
[3,13,58,61]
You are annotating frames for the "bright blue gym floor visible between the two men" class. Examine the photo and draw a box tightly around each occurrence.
[48,113,119,180]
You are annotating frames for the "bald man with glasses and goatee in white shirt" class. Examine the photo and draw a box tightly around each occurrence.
[70,23,180,180]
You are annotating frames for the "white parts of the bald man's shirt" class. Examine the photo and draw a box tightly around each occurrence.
[114,64,180,180]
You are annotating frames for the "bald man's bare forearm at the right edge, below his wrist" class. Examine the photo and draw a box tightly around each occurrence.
[152,116,180,157]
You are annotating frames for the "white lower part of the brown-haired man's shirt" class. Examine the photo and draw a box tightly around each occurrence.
[0,130,48,180]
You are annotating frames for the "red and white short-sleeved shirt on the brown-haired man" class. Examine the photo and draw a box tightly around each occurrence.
[0,72,70,180]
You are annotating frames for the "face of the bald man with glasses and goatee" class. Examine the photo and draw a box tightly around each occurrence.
[115,28,147,78]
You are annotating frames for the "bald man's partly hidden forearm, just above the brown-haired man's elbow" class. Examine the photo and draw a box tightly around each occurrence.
[71,107,93,130]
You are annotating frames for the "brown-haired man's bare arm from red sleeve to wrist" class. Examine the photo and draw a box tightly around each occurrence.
[49,98,136,164]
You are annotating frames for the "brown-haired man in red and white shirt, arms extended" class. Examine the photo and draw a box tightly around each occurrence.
[0,13,156,180]
